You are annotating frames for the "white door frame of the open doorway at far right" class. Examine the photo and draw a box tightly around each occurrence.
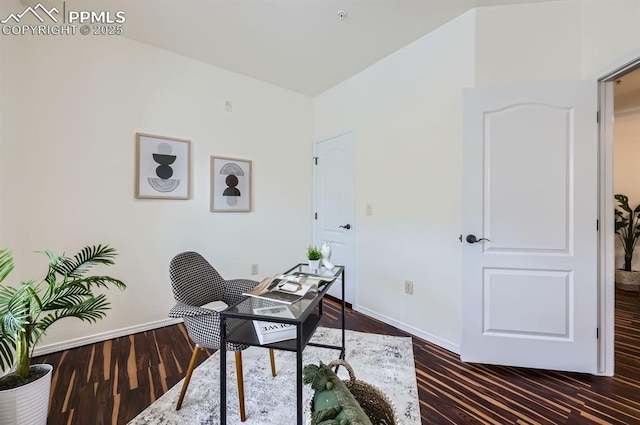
[593,50,640,376]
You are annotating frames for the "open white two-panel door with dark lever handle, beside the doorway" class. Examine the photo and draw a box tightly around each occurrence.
[461,82,598,373]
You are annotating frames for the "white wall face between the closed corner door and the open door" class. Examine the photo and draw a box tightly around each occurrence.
[314,13,475,349]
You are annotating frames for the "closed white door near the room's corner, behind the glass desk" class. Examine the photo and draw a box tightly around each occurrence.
[313,132,356,304]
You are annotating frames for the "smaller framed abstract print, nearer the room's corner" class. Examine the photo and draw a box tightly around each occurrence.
[211,156,252,212]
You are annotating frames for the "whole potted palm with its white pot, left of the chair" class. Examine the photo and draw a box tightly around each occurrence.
[0,245,126,425]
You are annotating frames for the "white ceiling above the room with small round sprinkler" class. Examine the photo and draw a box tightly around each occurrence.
[27,0,559,96]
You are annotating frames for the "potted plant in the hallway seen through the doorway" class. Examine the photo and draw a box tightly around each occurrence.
[614,194,640,292]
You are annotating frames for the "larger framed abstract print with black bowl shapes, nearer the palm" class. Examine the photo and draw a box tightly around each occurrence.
[136,133,191,199]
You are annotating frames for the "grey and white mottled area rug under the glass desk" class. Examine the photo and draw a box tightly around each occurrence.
[129,328,421,425]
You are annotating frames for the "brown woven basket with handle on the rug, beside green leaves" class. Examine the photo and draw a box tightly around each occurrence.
[307,360,399,425]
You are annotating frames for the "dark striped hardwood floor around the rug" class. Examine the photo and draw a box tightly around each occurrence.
[35,292,640,425]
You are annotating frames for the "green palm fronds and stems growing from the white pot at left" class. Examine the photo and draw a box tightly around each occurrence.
[0,245,126,386]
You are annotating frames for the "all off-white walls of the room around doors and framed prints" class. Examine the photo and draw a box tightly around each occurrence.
[6,0,640,358]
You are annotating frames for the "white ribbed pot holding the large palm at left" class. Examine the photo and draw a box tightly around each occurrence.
[0,364,53,425]
